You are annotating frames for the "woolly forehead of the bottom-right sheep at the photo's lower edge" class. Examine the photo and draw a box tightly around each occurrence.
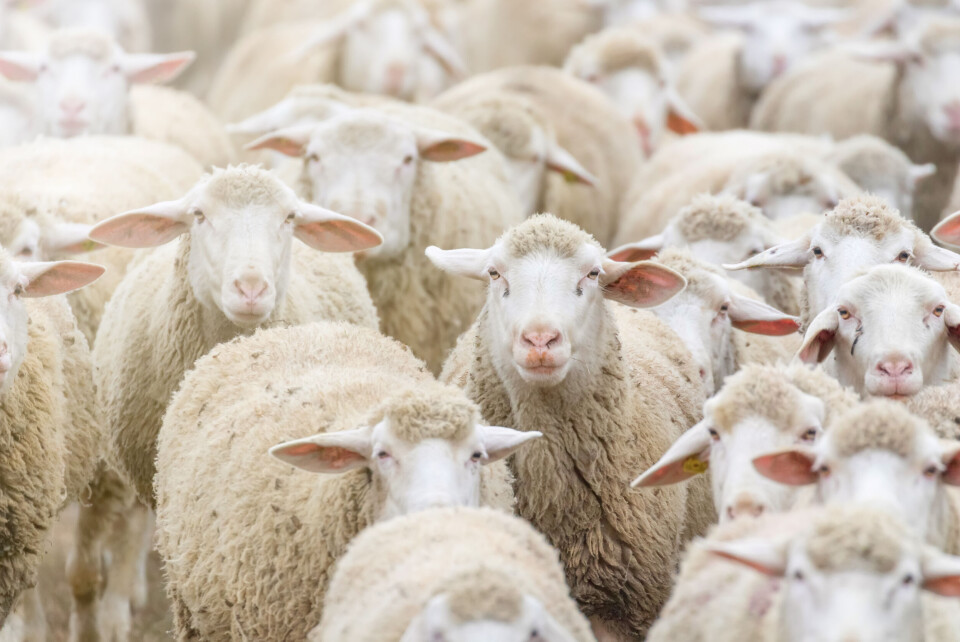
[802,506,913,573]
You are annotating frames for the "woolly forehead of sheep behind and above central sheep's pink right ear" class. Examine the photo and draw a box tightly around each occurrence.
[673,194,765,243]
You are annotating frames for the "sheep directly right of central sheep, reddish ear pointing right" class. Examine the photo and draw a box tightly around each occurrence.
[651,250,800,397]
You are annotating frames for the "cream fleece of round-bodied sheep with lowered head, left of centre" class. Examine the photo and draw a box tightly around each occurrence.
[157,323,513,642]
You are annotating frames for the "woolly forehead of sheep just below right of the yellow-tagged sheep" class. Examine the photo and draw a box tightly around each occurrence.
[825,400,930,460]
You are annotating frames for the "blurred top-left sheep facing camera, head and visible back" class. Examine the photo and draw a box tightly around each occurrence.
[0,29,234,167]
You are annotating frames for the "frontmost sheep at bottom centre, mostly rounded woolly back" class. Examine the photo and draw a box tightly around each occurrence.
[307,508,596,642]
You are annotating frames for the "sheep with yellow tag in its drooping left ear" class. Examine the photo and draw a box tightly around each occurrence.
[633,364,858,524]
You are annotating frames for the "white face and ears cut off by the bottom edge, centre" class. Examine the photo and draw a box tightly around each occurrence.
[400,594,574,642]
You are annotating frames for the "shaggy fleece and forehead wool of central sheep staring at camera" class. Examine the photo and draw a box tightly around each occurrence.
[446,215,716,640]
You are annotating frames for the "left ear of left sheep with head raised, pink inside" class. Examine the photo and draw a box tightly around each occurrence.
[90,201,191,249]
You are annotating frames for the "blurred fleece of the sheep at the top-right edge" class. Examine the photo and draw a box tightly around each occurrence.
[751,16,960,229]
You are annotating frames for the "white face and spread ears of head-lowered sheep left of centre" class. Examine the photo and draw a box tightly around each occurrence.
[270,416,541,520]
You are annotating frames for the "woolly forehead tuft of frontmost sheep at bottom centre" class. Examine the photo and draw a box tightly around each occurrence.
[437,566,523,623]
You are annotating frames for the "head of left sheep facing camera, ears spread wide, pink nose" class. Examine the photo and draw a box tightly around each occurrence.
[90,167,380,328]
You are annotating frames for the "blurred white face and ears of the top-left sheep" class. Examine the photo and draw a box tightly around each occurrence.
[0,30,193,138]
